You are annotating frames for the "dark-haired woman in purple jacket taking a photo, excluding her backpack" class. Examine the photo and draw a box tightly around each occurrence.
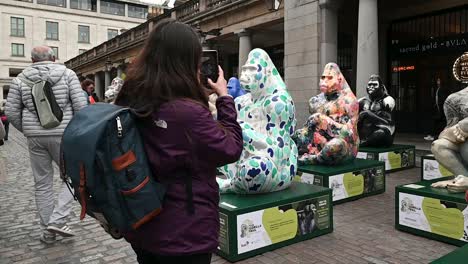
[115,19,242,264]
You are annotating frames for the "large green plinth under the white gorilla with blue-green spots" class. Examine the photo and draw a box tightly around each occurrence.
[217,182,333,262]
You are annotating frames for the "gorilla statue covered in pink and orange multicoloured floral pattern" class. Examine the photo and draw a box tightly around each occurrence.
[293,63,359,165]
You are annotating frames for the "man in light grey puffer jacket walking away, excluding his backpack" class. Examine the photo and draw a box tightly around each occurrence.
[6,46,86,243]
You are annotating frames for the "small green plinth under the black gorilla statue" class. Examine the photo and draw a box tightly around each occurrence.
[357,144,416,172]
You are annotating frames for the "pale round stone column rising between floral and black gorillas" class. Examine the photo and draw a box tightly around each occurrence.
[356,0,379,98]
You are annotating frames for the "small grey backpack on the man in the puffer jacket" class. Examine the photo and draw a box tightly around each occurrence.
[18,76,63,128]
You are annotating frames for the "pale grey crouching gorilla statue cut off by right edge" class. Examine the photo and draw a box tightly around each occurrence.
[431,87,468,192]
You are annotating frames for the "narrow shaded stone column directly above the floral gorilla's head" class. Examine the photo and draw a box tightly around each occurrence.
[319,0,338,68]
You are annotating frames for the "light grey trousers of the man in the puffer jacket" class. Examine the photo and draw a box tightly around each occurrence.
[28,136,73,228]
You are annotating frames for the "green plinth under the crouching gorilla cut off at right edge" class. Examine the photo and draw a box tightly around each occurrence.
[395,177,468,246]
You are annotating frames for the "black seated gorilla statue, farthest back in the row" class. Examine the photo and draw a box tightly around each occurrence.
[358,75,395,147]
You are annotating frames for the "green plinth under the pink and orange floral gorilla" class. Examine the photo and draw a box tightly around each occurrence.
[295,159,385,204]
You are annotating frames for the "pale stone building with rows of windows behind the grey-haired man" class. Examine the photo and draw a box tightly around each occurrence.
[0,0,152,102]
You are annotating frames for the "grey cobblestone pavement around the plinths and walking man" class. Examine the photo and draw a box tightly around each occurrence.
[0,129,456,264]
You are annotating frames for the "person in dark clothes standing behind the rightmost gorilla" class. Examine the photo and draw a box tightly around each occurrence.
[424,78,450,141]
